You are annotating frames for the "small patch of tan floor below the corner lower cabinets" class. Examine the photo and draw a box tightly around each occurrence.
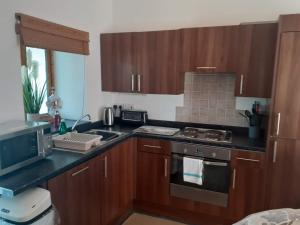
[123,213,184,225]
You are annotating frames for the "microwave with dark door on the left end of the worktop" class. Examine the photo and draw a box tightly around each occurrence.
[0,121,52,176]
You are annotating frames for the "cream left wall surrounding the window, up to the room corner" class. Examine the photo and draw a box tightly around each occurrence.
[0,0,112,122]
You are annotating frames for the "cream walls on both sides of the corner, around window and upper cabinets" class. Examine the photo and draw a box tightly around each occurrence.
[0,0,300,122]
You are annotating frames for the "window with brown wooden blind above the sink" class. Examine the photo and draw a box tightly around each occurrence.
[15,13,89,120]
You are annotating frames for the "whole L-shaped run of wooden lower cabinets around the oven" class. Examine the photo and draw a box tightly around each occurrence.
[48,135,268,225]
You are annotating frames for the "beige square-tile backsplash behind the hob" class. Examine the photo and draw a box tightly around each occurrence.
[176,73,248,127]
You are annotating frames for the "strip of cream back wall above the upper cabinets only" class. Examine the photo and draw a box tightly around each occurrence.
[113,0,300,31]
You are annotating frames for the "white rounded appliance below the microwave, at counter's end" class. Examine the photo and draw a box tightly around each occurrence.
[0,188,57,225]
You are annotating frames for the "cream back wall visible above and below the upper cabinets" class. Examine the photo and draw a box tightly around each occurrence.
[108,0,300,120]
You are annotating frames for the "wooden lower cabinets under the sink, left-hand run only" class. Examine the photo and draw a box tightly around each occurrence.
[48,139,136,225]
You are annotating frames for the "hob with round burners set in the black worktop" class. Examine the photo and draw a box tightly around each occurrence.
[175,127,232,143]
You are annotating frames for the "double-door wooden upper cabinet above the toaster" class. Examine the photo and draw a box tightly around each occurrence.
[101,30,183,94]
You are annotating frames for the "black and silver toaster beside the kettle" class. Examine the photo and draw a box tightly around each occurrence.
[121,110,148,124]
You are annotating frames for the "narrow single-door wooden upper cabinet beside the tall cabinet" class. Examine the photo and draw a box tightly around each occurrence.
[235,23,278,98]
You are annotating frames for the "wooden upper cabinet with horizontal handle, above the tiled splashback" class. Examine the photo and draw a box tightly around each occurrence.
[181,26,238,73]
